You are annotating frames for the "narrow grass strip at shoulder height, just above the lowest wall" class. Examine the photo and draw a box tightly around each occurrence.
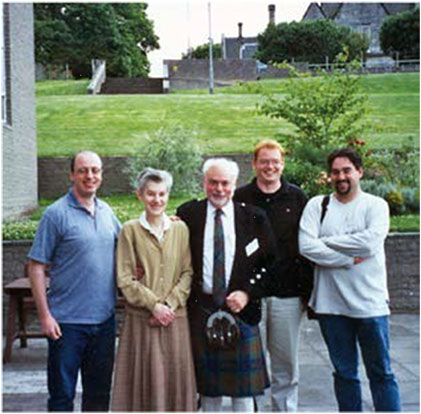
[2,194,420,240]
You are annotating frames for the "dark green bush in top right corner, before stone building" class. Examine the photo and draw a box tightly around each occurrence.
[380,6,420,59]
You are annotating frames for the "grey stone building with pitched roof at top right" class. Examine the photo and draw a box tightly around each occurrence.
[303,2,417,58]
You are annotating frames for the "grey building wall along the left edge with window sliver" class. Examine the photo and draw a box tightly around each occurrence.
[0,3,37,219]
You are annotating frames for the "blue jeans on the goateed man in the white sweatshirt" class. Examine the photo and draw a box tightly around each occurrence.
[319,315,401,412]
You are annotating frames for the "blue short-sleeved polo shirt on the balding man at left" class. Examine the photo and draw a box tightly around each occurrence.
[28,189,121,324]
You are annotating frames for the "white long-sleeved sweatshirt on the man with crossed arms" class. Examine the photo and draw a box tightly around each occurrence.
[299,192,390,318]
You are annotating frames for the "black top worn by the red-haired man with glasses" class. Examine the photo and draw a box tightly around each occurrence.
[234,177,312,299]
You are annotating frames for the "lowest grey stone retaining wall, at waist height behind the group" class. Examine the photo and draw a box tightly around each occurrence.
[3,233,420,330]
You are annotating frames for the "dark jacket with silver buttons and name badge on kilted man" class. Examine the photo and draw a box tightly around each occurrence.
[177,199,277,325]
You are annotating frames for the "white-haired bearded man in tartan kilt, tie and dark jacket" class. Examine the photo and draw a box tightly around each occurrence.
[177,158,276,412]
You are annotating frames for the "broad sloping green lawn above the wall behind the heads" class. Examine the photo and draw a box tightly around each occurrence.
[37,73,419,156]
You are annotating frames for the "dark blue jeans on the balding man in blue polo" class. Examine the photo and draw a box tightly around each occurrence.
[48,316,116,411]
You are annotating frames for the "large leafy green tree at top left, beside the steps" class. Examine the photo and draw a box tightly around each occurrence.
[34,3,159,77]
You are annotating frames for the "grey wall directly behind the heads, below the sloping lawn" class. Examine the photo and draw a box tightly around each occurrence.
[38,154,252,198]
